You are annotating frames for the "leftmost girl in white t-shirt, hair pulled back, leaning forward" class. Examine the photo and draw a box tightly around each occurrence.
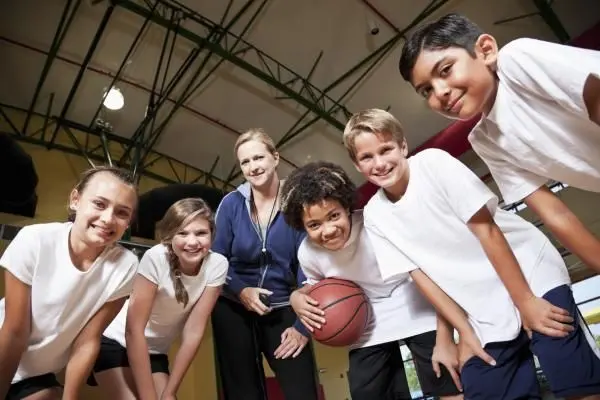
[0,167,138,400]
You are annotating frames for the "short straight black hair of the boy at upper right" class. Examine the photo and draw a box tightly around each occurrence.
[399,13,484,82]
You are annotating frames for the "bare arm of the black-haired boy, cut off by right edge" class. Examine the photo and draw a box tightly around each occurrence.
[525,186,600,272]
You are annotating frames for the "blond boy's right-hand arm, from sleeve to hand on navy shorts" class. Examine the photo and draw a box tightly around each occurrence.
[467,207,573,337]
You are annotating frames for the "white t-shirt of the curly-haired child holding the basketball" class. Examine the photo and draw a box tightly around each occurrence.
[298,211,436,348]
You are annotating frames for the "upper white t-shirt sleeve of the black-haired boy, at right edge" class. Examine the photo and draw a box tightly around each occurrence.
[498,38,600,118]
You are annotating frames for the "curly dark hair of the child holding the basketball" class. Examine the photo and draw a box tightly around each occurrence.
[281,161,356,230]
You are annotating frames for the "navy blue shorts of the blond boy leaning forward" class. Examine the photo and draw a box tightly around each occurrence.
[461,285,600,400]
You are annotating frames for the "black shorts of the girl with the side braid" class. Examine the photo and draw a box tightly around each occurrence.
[88,336,169,378]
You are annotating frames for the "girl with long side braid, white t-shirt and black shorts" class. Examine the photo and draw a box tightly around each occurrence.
[94,198,228,400]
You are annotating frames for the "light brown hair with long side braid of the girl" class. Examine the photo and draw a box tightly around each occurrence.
[157,198,215,307]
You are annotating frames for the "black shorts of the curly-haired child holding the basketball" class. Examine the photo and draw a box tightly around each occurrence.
[348,331,461,400]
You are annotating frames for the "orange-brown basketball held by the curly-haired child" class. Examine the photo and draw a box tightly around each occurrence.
[307,278,370,347]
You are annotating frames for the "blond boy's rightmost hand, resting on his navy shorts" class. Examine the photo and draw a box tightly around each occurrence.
[519,296,575,337]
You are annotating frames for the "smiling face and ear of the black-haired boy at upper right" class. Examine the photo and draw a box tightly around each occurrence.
[411,35,498,120]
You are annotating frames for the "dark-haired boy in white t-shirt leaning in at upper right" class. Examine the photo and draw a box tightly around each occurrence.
[400,14,600,272]
